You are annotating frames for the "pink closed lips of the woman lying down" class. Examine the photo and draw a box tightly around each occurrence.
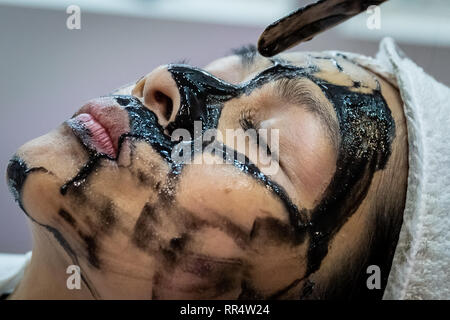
[67,97,130,159]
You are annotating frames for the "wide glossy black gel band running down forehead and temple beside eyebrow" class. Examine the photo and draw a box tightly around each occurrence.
[308,80,395,278]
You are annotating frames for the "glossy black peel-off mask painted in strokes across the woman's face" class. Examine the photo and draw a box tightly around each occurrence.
[8,61,395,297]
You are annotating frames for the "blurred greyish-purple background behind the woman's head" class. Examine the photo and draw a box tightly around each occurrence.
[0,5,450,253]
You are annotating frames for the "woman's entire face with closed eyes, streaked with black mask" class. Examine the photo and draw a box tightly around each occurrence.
[8,50,395,299]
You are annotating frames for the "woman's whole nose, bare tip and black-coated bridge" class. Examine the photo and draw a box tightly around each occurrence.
[133,64,241,135]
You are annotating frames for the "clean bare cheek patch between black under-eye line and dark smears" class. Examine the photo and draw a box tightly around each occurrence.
[177,155,287,233]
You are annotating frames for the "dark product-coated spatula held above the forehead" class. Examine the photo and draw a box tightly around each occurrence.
[258,0,387,57]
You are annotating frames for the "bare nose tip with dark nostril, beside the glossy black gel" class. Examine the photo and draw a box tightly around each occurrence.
[132,66,180,127]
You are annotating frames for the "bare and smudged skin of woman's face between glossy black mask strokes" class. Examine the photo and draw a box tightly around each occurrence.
[6,48,407,299]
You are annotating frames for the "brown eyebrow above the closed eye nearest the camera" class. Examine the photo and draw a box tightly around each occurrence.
[276,79,340,151]
